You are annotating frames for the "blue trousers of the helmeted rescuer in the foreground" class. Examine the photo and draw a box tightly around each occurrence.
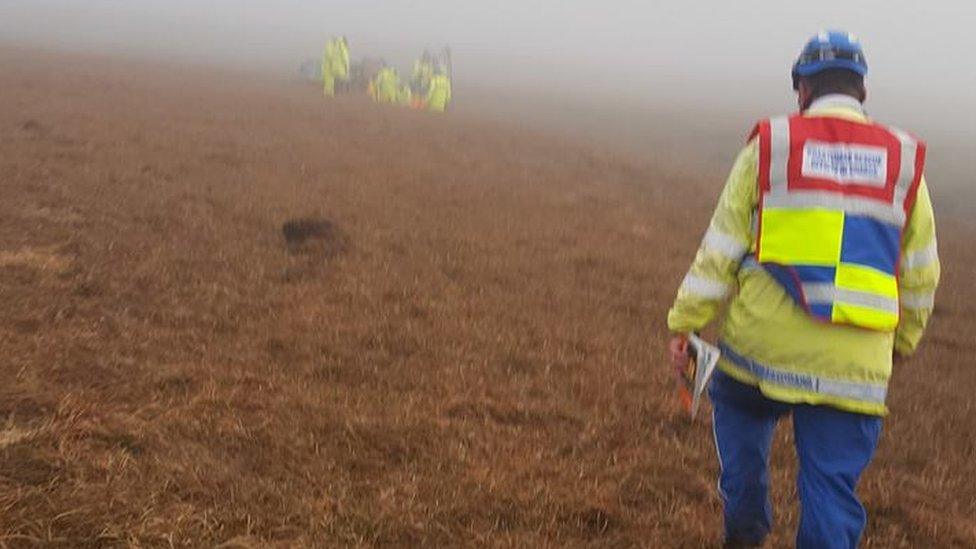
[709,371,881,549]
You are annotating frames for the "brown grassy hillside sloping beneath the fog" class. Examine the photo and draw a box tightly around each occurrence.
[0,49,976,548]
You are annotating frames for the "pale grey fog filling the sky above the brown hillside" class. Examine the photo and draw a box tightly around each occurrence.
[0,0,976,193]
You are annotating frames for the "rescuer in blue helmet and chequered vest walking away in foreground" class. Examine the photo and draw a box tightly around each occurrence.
[668,32,940,548]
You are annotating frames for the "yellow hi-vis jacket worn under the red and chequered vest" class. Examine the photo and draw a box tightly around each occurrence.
[668,96,940,415]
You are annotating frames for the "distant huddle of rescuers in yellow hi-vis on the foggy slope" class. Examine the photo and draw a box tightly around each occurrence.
[322,36,451,112]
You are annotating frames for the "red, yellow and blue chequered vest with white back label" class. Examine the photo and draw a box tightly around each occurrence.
[755,115,926,331]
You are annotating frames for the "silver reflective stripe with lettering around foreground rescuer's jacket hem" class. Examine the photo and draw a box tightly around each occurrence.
[719,342,888,404]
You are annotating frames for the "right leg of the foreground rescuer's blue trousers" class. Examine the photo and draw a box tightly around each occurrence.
[793,406,881,549]
